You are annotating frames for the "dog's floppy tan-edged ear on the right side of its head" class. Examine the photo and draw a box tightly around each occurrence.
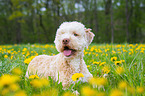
[85,28,95,47]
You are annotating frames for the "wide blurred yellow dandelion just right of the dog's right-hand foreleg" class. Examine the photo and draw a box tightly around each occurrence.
[89,77,107,86]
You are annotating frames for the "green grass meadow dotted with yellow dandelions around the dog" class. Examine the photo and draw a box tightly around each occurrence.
[0,44,145,96]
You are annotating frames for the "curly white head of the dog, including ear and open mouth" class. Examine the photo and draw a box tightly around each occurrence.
[54,21,95,57]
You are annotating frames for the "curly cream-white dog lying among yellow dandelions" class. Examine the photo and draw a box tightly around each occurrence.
[26,21,94,87]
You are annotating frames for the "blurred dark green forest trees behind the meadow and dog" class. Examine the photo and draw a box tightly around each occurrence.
[0,0,145,44]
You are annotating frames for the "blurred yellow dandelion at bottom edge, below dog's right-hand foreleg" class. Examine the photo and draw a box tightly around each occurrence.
[81,86,97,96]
